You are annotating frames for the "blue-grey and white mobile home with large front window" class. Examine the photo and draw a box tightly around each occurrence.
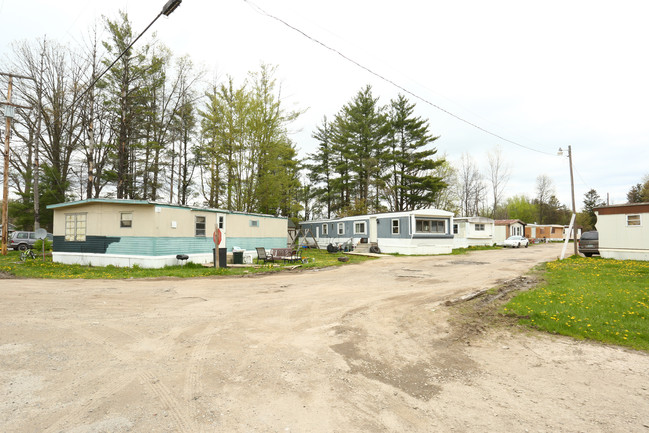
[300,209,453,254]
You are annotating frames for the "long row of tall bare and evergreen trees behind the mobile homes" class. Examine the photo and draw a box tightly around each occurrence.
[1,13,446,228]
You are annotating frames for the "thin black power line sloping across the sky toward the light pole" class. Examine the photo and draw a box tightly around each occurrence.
[243,0,555,156]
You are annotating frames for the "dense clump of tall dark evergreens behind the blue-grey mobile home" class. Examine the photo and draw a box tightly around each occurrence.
[305,86,447,218]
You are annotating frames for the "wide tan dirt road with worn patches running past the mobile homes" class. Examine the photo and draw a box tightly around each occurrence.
[0,245,649,433]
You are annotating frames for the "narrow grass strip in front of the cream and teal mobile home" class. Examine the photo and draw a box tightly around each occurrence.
[0,249,371,279]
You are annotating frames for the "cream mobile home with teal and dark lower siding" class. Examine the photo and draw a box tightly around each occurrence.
[48,199,288,268]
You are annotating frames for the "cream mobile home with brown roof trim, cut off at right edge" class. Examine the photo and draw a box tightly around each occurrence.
[595,203,649,260]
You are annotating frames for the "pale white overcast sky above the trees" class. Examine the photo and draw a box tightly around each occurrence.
[0,0,649,208]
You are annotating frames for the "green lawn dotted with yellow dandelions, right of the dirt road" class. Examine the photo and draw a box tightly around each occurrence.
[503,257,649,351]
